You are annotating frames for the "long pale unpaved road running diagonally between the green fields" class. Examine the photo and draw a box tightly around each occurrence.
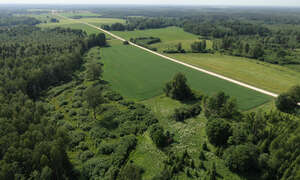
[55,14,300,106]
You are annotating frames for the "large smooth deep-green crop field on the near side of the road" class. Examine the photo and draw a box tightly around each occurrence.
[101,41,272,110]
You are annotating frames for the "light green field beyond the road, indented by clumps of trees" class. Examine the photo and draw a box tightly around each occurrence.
[113,27,212,52]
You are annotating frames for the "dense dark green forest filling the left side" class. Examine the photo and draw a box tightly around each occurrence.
[0,14,105,179]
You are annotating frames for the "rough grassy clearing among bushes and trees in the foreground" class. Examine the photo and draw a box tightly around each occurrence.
[142,96,242,180]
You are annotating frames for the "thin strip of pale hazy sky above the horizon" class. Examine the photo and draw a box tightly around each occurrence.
[0,0,300,7]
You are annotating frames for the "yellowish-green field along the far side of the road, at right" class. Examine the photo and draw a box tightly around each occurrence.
[168,53,300,93]
